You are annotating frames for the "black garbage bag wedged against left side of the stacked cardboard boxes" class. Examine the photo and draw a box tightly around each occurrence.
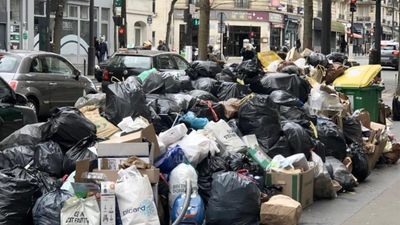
[63,137,97,174]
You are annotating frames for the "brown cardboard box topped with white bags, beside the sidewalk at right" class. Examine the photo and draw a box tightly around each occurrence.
[266,168,314,209]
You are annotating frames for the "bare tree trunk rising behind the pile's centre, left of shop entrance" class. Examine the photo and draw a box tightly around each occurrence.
[198,0,212,60]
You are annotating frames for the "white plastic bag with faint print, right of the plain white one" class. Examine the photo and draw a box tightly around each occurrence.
[205,120,246,152]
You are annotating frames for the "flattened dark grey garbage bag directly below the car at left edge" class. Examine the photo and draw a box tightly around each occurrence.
[0,123,51,151]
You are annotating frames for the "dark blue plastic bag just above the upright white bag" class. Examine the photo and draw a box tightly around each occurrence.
[154,145,188,174]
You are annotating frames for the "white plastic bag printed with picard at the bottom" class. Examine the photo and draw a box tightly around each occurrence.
[115,166,160,225]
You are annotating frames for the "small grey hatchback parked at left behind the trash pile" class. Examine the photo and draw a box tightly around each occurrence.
[0,50,96,116]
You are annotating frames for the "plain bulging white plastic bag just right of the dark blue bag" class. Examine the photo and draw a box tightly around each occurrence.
[176,131,219,166]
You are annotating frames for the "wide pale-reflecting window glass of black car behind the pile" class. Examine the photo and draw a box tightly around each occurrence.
[109,55,151,69]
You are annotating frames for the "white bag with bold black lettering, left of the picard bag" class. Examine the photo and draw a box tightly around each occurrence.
[61,196,100,225]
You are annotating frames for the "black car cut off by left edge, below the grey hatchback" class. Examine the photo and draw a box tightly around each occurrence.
[0,77,37,141]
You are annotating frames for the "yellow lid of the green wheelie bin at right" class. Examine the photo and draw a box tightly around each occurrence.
[333,65,382,87]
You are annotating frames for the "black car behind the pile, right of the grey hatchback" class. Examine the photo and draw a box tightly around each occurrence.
[97,50,189,88]
